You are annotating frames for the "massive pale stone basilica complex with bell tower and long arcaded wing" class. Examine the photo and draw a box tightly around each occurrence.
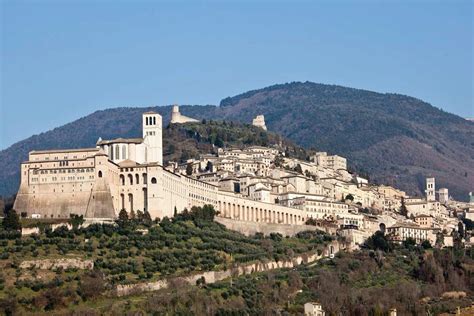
[14,112,306,224]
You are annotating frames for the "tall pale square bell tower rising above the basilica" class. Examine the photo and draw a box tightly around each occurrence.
[142,112,163,165]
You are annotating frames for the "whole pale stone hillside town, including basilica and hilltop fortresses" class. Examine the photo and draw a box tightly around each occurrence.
[10,105,474,249]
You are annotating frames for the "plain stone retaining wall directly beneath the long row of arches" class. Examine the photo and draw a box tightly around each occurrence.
[214,217,335,237]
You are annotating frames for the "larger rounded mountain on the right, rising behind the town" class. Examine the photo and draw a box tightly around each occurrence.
[219,82,474,200]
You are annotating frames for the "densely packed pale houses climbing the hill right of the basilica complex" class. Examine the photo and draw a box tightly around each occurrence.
[167,108,474,248]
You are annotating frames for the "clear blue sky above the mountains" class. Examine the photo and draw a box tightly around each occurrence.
[0,0,474,150]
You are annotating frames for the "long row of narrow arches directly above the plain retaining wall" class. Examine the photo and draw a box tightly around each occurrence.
[219,201,305,224]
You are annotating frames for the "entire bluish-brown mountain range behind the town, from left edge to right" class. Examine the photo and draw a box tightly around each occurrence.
[0,82,474,200]
